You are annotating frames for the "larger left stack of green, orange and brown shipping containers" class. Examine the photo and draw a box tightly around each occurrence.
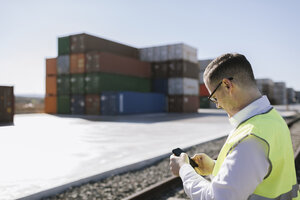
[45,34,166,115]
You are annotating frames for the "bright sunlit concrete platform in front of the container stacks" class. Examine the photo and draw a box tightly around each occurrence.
[0,109,298,199]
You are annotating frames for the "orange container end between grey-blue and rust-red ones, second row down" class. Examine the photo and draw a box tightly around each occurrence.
[70,53,85,74]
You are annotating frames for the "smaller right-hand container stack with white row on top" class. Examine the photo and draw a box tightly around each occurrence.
[140,44,199,112]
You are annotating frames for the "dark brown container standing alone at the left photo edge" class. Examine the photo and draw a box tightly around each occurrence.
[0,86,15,123]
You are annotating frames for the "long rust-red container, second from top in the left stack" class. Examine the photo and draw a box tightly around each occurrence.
[86,52,151,78]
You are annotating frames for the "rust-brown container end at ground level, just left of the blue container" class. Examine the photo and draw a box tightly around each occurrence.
[85,94,100,115]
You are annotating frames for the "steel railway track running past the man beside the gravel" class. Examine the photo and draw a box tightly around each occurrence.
[123,115,300,200]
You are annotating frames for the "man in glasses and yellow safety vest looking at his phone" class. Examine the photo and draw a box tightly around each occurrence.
[170,54,300,200]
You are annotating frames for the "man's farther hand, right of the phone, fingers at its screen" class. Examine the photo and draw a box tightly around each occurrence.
[192,153,215,176]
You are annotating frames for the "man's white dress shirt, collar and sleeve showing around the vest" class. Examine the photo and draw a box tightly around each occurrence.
[179,96,272,200]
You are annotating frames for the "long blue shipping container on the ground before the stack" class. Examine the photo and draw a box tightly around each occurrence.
[100,92,167,115]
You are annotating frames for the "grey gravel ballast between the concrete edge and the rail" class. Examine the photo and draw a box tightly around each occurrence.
[45,138,226,200]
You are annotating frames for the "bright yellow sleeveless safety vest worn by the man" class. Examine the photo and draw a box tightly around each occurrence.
[213,109,300,200]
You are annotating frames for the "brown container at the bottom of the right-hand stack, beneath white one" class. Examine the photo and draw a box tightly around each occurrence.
[168,95,199,113]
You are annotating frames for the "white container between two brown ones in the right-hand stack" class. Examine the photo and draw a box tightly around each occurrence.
[168,78,199,96]
